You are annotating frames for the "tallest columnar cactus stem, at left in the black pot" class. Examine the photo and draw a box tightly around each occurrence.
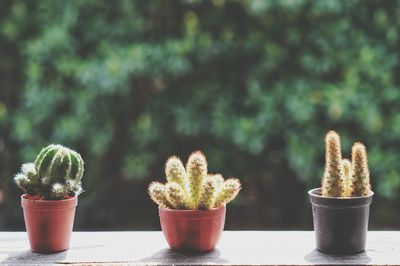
[322,130,344,197]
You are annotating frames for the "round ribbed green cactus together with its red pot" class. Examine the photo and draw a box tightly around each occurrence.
[14,145,84,253]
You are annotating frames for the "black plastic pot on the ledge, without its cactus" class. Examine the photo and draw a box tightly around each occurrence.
[308,188,374,254]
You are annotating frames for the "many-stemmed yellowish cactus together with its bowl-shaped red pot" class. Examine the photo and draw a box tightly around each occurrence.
[148,151,241,253]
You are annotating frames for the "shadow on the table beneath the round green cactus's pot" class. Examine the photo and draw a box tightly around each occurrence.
[0,250,67,265]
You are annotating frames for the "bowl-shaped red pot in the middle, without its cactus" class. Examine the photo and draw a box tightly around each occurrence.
[158,206,226,253]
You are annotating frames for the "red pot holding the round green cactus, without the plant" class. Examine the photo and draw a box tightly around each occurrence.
[21,194,78,253]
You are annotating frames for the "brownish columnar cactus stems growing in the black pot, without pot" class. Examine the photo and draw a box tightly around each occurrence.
[321,130,371,197]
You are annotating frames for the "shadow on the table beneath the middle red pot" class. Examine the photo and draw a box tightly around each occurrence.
[140,248,228,265]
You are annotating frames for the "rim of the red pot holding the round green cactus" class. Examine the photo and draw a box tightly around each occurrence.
[21,194,78,209]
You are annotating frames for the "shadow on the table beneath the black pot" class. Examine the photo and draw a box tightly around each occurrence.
[304,249,371,265]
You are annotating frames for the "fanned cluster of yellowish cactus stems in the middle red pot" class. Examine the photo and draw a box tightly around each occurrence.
[148,151,241,210]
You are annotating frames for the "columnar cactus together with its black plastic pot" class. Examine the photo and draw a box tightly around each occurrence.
[308,131,374,254]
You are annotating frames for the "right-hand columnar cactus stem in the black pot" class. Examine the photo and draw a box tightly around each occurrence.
[351,142,371,196]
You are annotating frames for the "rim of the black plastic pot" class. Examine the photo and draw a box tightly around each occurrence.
[308,188,374,209]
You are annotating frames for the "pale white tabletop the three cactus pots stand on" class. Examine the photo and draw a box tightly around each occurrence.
[0,231,400,265]
